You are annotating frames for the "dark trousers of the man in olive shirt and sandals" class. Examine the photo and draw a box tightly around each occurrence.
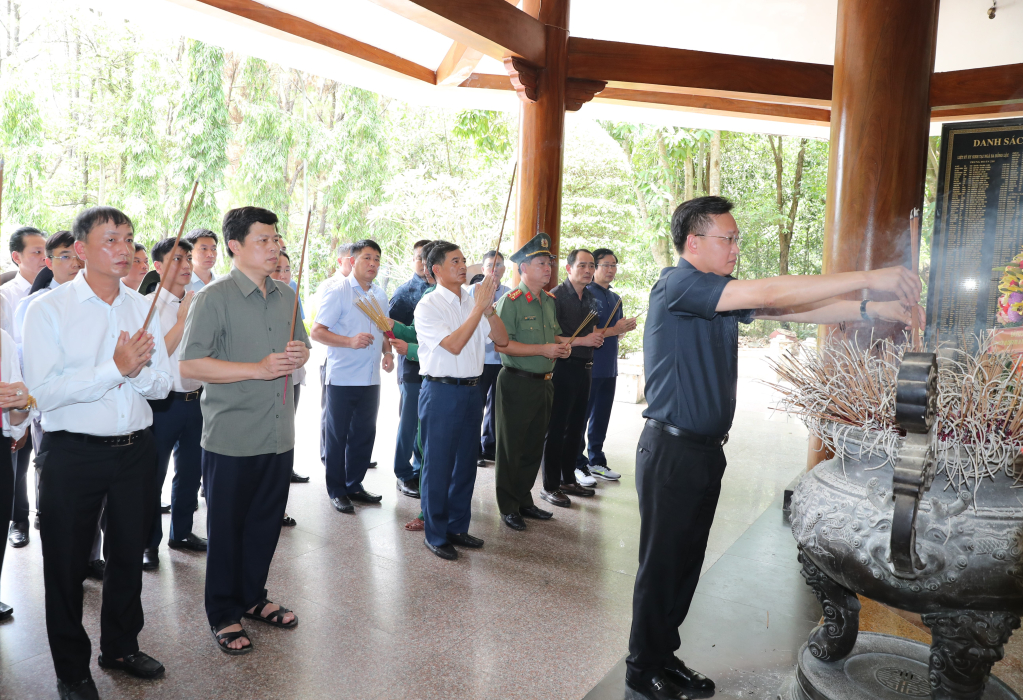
[203,449,295,628]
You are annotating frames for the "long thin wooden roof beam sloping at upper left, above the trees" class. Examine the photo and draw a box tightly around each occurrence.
[186,0,436,84]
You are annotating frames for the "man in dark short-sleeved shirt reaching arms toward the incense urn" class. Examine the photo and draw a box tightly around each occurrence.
[625,196,921,700]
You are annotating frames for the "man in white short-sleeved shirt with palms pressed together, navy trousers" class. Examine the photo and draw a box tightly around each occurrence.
[415,240,508,559]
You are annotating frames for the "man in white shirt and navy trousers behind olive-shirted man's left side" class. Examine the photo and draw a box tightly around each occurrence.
[142,238,207,570]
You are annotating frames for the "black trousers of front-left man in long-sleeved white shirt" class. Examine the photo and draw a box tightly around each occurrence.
[36,430,157,683]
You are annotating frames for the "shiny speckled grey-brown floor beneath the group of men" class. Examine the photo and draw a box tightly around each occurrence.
[0,351,808,700]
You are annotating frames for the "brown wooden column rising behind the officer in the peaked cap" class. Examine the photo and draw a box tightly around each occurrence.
[505,0,569,287]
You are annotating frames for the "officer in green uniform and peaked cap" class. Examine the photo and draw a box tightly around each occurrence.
[494,233,572,530]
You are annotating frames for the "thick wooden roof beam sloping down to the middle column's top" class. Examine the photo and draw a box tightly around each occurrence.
[372,0,545,67]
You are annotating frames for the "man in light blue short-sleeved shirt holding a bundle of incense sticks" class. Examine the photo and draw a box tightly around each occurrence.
[310,239,394,513]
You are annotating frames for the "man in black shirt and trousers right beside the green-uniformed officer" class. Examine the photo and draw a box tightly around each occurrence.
[540,249,604,508]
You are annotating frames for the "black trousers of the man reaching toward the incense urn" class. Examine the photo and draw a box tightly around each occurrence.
[626,427,725,677]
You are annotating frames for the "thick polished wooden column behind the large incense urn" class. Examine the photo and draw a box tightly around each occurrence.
[808,0,938,467]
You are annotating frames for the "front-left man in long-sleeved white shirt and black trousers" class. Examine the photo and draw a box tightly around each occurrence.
[25,207,171,700]
